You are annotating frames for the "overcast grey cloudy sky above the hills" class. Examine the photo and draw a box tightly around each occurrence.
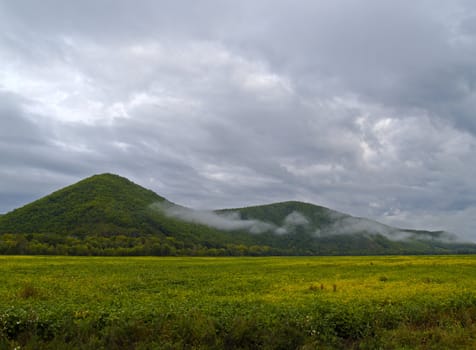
[0,0,476,241]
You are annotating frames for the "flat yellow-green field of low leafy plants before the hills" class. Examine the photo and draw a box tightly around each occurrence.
[0,256,476,349]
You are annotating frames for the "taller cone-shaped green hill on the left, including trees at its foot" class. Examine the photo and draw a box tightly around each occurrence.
[0,174,262,255]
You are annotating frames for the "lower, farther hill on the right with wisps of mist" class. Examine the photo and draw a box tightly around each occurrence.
[219,201,476,255]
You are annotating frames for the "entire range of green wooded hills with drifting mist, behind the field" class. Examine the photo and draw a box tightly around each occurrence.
[0,174,476,255]
